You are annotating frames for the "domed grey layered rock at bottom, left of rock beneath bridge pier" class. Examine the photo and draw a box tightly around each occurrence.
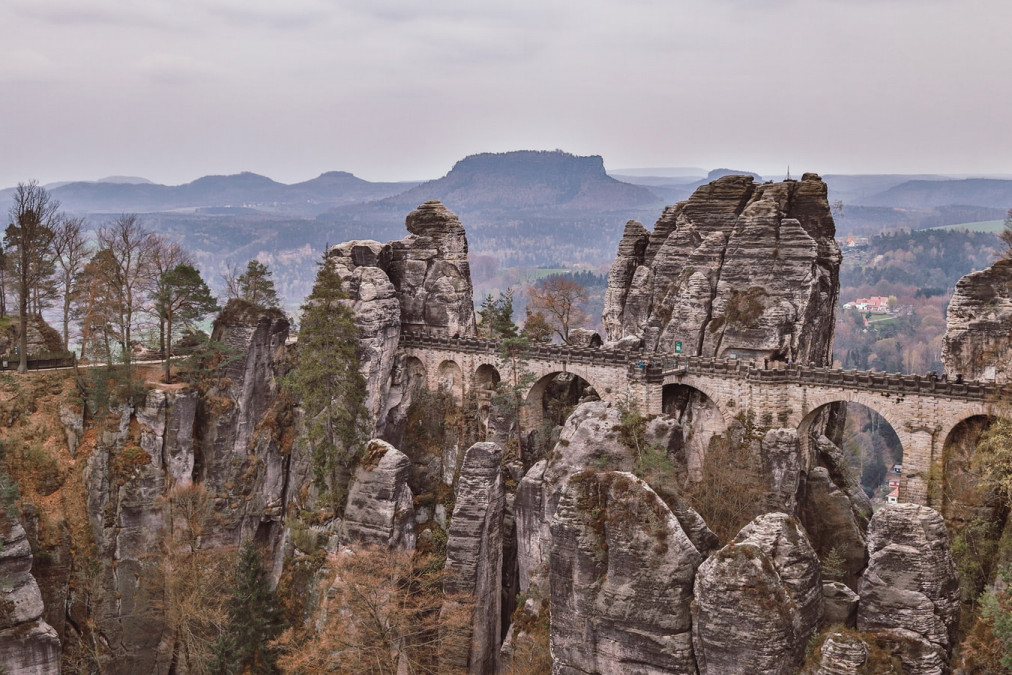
[692,513,823,675]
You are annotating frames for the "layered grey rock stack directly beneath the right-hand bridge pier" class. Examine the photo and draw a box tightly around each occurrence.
[857,504,959,673]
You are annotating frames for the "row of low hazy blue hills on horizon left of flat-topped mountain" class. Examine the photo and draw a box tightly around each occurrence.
[0,171,417,217]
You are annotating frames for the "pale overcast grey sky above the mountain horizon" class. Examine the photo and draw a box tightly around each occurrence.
[0,0,1012,186]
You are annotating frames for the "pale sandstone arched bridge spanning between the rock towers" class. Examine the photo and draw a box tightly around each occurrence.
[400,333,1012,504]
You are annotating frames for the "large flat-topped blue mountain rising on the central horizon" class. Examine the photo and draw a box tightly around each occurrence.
[320,151,664,266]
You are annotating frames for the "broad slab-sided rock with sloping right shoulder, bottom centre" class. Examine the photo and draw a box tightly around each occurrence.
[551,471,702,674]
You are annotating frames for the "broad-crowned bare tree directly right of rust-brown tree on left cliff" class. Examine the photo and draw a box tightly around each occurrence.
[98,214,157,363]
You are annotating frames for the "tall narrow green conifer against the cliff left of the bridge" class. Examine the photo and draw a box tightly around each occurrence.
[290,257,368,511]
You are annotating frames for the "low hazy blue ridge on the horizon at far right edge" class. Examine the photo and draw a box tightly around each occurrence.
[858,178,1012,208]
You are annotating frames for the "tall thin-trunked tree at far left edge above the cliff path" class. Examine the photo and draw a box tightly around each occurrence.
[4,180,60,372]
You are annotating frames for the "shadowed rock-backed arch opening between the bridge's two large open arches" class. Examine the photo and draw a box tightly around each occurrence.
[661,383,728,482]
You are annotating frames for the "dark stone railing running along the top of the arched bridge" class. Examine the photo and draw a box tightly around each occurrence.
[401,331,1012,401]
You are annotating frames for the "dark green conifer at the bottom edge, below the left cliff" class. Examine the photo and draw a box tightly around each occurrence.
[212,539,282,675]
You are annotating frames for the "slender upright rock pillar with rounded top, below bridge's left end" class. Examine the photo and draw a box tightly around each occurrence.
[440,443,506,674]
